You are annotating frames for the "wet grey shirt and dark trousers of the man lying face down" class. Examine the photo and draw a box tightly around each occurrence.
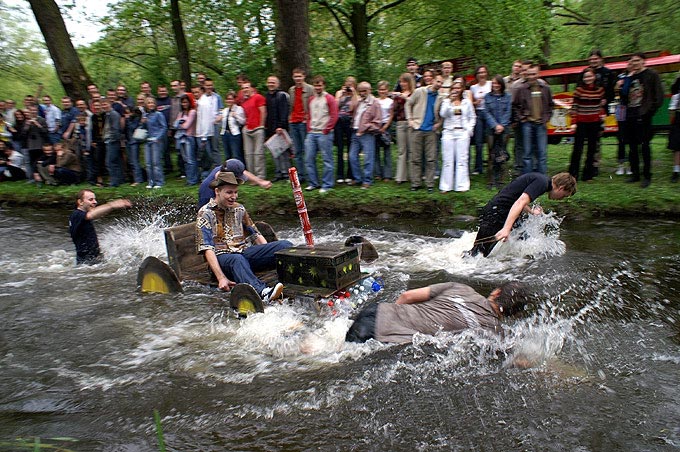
[345,282,501,344]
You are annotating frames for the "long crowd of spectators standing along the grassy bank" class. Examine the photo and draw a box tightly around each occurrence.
[0,50,668,193]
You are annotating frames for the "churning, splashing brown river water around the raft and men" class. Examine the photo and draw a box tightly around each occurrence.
[0,207,680,451]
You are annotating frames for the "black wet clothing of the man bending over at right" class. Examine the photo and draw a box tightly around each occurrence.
[470,173,552,257]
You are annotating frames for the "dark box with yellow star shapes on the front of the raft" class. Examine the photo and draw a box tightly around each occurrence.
[276,246,361,290]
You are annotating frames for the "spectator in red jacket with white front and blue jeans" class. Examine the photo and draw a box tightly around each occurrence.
[305,75,338,193]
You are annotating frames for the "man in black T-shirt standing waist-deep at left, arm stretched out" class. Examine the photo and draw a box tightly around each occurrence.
[68,190,132,265]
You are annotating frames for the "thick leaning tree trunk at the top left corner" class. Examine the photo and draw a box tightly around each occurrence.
[28,0,92,100]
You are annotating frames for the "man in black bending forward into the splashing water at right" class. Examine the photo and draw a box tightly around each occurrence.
[468,173,576,257]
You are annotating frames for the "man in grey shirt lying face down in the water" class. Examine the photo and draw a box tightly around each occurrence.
[345,282,527,344]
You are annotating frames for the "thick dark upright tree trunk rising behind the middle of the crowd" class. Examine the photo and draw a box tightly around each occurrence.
[275,0,310,90]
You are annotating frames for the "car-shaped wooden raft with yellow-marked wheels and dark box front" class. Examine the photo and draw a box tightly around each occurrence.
[137,222,378,315]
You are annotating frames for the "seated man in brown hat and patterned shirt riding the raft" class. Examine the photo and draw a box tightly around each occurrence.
[196,171,293,302]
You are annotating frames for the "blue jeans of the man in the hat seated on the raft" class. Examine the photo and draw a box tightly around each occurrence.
[217,240,293,293]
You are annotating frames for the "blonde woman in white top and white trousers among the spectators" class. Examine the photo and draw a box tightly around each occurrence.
[439,81,477,193]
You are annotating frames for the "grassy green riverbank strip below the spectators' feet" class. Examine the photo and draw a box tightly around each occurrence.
[0,135,680,223]
